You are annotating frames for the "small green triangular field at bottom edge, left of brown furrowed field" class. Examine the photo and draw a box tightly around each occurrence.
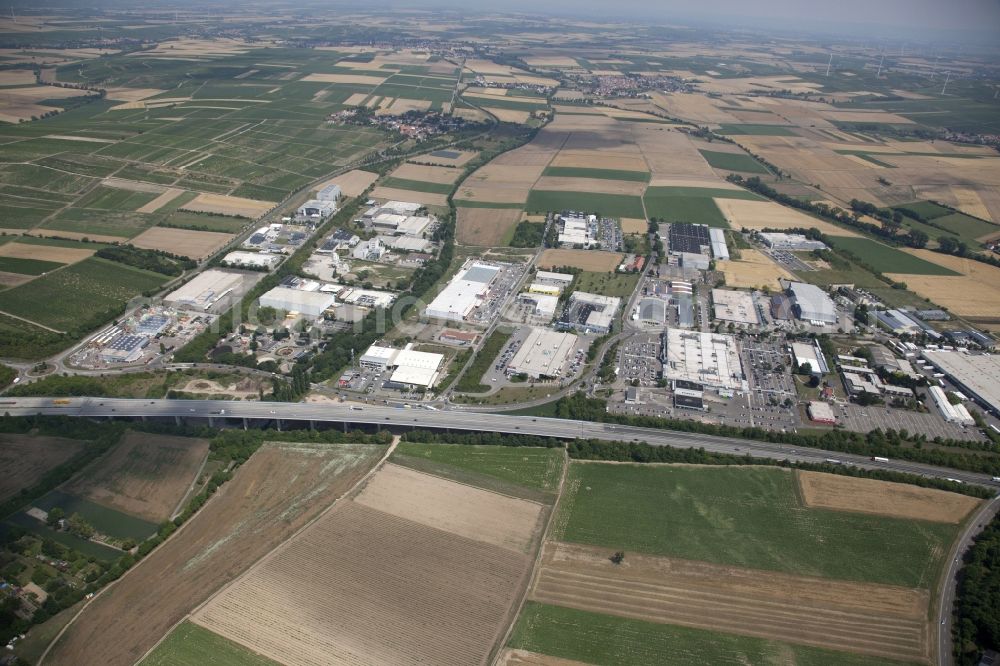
[139,622,280,666]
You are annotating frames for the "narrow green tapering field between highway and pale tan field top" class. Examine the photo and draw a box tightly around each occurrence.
[393,442,564,492]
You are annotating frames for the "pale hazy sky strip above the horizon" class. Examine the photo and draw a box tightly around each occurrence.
[402,0,1000,38]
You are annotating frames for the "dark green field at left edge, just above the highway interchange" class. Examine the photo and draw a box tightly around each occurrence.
[0,257,166,331]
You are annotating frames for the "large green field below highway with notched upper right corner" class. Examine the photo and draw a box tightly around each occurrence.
[552,463,958,588]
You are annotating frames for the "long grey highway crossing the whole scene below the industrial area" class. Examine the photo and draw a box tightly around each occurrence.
[7,398,1000,491]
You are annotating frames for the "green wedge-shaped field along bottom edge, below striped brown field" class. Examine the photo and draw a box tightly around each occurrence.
[507,601,901,666]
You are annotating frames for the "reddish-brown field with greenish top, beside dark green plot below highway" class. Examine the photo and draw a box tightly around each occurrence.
[62,431,208,523]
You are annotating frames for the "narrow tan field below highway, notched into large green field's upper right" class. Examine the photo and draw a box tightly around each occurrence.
[796,471,981,524]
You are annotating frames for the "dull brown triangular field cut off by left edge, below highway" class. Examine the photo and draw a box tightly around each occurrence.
[0,433,84,501]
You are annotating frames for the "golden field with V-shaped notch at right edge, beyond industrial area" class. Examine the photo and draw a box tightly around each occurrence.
[887,249,1000,321]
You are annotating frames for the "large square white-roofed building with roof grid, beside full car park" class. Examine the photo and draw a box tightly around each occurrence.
[661,328,747,391]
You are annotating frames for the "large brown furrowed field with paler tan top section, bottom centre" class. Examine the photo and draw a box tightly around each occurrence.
[193,464,544,666]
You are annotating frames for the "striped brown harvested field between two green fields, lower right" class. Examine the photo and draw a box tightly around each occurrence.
[530,542,931,662]
